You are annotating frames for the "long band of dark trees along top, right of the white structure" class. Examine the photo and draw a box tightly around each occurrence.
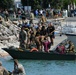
[21,0,76,9]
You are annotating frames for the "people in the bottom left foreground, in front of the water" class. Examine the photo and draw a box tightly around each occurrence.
[0,59,26,75]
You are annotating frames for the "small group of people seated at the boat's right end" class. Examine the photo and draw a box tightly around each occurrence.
[55,40,75,54]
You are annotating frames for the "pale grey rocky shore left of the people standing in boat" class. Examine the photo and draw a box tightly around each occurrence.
[0,16,20,57]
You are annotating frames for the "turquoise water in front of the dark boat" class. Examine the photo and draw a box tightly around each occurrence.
[0,58,76,75]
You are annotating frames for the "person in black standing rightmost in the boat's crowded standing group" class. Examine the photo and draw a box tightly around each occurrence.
[46,22,55,45]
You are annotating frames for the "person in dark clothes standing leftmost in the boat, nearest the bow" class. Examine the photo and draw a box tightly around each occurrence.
[19,26,27,49]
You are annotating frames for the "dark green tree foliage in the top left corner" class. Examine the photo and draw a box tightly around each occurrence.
[0,0,14,9]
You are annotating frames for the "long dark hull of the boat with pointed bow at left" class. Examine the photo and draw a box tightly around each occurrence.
[3,48,76,60]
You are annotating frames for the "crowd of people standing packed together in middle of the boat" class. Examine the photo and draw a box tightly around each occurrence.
[19,22,55,52]
